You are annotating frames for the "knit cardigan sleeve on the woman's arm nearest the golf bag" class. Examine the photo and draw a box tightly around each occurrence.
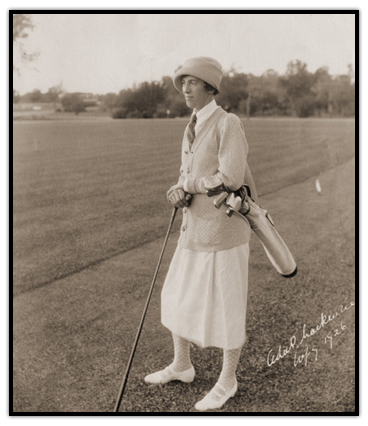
[185,114,248,194]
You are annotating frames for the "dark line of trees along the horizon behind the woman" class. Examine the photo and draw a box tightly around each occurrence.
[13,60,355,118]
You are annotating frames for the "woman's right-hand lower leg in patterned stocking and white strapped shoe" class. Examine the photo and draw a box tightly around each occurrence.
[195,347,242,411]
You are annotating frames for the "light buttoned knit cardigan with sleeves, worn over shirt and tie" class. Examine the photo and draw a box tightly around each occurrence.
[178,107,251,252]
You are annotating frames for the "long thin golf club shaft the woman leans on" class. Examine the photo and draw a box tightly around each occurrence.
[114,207,178,413]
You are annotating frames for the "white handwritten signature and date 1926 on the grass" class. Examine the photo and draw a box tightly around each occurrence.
[267,301,355,367]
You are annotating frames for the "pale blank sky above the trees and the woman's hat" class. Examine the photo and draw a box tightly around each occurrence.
[14,11,355,94]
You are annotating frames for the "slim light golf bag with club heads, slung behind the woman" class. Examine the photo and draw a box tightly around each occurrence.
[206,185,297,278]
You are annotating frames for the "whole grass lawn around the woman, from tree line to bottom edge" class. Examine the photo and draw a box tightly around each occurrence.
[13,116,355,412]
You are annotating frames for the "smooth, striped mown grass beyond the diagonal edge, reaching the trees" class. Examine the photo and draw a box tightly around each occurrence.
[13,119,355,295]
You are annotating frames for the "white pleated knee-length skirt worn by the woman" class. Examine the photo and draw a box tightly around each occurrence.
[161,243,249,349]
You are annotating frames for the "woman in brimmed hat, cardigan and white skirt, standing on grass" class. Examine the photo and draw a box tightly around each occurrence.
[145,57,258,411]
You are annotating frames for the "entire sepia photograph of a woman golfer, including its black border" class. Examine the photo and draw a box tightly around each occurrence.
[12,7,359,416]
